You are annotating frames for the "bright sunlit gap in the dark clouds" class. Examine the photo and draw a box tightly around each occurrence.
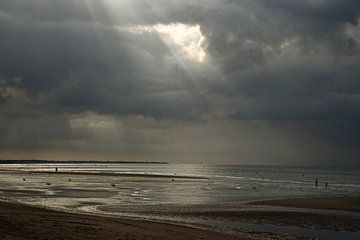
[121,23,206,62]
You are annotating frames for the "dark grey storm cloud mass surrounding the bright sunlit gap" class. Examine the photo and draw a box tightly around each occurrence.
[0,0,360,165]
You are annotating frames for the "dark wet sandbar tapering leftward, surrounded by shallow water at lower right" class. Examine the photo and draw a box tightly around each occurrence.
[99,197,360,232]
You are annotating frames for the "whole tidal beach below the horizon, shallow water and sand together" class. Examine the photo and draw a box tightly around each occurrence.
[0,163,360,240]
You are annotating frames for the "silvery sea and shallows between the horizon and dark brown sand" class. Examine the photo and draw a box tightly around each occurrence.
[0,163,360,239]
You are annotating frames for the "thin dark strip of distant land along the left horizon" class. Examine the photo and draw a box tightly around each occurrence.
[0,159,168,164]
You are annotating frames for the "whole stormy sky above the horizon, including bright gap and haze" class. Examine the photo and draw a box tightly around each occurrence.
[0,0,360,166]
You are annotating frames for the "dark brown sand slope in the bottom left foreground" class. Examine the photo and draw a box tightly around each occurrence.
[0,202,239,240]
